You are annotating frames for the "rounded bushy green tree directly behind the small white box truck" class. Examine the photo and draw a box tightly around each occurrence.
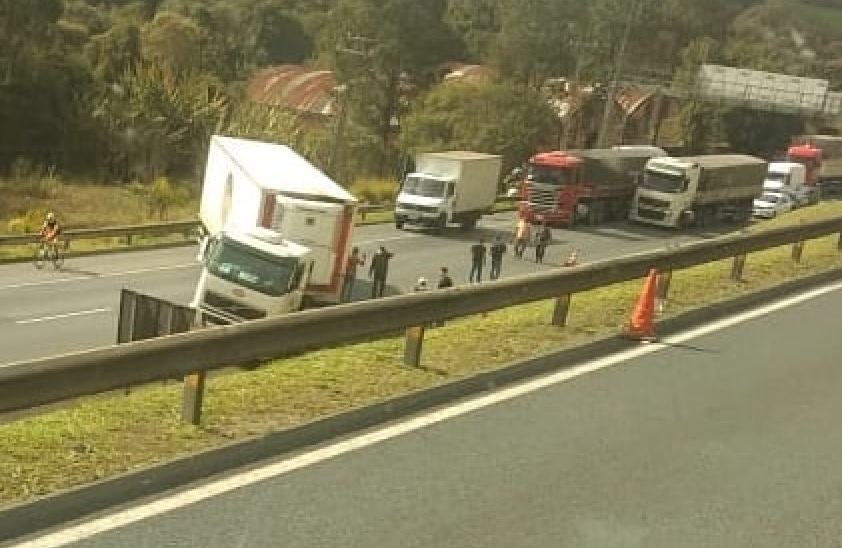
[401,83,559,169]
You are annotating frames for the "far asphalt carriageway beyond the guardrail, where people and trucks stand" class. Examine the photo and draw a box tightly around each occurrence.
[0,213,712,364]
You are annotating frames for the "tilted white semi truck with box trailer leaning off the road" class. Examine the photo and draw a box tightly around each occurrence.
[192,136,357,324]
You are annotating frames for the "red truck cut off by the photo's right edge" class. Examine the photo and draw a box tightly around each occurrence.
[787,135,842,196]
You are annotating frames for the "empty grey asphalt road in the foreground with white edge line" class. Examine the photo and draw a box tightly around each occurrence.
[11,278,842,548]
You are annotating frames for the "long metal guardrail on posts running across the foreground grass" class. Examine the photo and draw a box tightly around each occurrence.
[0,218,842,418]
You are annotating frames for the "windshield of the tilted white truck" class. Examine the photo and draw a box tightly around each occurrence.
[207,238,298,297]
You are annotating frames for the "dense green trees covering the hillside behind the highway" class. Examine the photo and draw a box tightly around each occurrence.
[0,0,842,185]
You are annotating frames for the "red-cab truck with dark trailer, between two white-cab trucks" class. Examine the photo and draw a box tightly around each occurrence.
[519,146,667,226]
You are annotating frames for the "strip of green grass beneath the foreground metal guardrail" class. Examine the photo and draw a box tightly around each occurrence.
[0,200,842,504]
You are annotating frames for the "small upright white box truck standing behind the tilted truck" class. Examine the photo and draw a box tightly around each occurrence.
[395,151,503,229]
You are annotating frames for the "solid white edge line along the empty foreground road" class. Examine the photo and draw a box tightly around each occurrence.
[11,283,842,548]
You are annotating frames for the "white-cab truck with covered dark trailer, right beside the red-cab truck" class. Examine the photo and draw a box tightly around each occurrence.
[630,154,767,228]
